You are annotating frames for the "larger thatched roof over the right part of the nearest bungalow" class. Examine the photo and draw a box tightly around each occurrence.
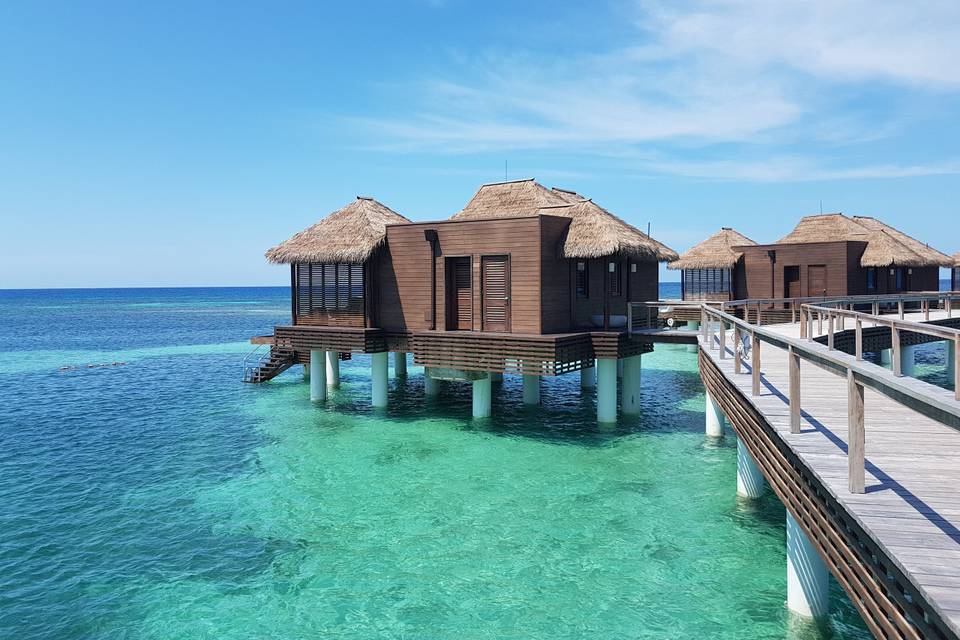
[451,178,677,261]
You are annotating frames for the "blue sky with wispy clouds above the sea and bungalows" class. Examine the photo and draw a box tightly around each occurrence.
[0,0,960,288]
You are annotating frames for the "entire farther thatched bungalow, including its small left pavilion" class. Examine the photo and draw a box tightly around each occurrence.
[669,213,954,300]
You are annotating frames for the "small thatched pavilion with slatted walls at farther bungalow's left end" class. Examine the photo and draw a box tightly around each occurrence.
[667,227,757,302]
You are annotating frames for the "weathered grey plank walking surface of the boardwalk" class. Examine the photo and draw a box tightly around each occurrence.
[700,311,960,635]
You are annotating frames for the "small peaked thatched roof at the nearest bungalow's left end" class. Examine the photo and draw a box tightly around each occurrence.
[266,196,410,264]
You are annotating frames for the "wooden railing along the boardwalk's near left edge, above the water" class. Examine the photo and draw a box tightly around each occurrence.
[701,305,960,493]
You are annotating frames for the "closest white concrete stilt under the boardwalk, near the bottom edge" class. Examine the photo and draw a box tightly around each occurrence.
[787,511,830,618]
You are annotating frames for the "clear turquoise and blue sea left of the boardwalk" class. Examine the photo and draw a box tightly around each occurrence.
[0,288,868,639]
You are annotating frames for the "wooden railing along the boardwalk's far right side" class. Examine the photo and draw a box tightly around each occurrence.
[801,300,960,400]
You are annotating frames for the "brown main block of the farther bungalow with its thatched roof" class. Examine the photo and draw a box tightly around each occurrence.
[734,213,953,298]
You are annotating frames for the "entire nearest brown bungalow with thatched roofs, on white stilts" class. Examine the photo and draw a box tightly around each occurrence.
[246,180,678,422]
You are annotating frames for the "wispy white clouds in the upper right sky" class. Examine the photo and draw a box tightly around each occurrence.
[354,0,960,170]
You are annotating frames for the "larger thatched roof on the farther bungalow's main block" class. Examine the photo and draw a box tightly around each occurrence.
[777,213,950,267]
